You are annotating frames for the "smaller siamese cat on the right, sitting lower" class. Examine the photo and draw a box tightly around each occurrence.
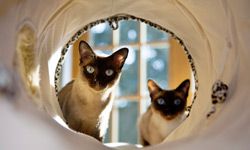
[139,79,190,146]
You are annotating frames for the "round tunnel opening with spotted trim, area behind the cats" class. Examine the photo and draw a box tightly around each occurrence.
[51,15,198,148]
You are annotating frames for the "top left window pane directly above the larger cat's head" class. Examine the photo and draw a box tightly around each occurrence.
[90,23,112,47]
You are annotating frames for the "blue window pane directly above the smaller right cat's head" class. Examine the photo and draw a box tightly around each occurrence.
[143,47,168,88]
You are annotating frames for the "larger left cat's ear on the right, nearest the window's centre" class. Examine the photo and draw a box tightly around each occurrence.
[112,48,128,69]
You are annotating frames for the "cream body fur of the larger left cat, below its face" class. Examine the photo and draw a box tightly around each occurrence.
[58,72,119,139]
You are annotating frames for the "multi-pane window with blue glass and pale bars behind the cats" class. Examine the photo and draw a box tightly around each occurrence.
[62,21,191,144]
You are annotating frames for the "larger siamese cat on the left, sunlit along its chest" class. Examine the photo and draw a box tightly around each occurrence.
[58,41,128,141]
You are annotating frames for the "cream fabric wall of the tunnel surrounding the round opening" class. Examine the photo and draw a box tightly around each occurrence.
[0,0,250,150]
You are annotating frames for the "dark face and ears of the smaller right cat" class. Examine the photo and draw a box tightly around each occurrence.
[148,79,190,120]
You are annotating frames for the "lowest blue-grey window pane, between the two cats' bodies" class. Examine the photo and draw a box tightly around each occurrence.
[116,100,138,144]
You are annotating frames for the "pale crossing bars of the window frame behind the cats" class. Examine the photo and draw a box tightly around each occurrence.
[84,20,169,143]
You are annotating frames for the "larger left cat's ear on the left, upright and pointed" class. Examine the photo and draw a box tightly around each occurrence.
[79,41,95,65]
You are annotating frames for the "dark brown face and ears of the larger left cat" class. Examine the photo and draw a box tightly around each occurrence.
[79,41,128,91]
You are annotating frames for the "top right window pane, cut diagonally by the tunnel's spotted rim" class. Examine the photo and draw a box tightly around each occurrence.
[147,25,167,42]
